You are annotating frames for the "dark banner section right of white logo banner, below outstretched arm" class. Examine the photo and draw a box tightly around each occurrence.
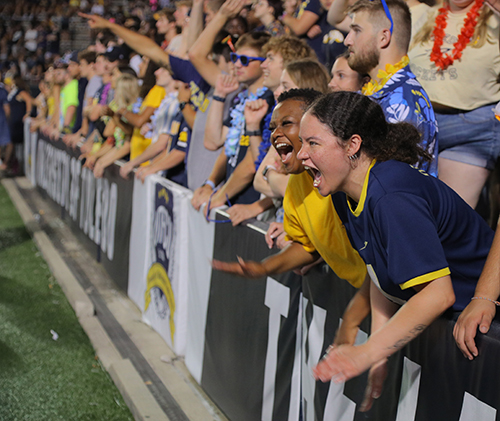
[201,218,301,421]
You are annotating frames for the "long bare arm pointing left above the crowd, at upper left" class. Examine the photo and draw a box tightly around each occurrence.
[78,12,170,65]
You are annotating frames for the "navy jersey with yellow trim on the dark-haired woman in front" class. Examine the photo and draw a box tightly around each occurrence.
[332,161,493,310]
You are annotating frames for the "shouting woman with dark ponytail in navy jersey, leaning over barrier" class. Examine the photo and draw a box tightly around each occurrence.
[297,92,493,404]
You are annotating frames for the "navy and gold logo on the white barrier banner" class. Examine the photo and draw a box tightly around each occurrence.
[144,184,175,343]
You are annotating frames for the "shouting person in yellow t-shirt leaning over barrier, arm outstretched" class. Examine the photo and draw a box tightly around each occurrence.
[212,89,398,411]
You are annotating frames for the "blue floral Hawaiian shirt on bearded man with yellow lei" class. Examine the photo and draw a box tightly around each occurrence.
[370,66,438,177]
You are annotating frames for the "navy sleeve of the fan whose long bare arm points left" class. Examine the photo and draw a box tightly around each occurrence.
[170,55,211,113]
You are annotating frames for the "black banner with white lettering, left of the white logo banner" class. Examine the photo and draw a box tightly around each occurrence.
[35,135,133,291]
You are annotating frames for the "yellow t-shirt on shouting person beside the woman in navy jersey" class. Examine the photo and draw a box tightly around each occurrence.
[283,171,366,288]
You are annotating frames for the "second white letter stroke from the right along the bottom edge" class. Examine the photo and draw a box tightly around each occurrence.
[396,357,422,421]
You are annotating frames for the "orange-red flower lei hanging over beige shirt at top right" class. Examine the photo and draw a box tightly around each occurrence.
[431,0,484,71]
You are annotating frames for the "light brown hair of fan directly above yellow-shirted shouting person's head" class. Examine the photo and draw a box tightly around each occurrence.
[285,58,330,93]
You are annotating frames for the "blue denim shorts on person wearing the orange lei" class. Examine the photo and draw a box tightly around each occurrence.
[435,104,500,170]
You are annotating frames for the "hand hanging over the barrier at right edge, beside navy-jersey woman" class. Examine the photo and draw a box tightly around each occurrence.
[453,300,496,360]
